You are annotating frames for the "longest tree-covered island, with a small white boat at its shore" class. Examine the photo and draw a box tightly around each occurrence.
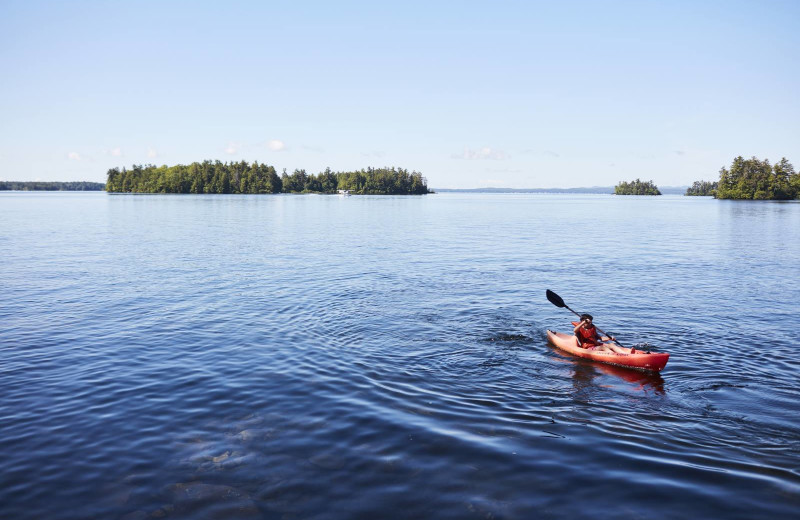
[106,161,432,195]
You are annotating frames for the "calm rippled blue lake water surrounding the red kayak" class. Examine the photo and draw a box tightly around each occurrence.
[0,193,800,520]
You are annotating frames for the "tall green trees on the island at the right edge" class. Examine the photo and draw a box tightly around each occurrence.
[716,156,800,200]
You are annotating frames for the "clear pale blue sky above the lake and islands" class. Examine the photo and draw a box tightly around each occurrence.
[0,0,800,188]
